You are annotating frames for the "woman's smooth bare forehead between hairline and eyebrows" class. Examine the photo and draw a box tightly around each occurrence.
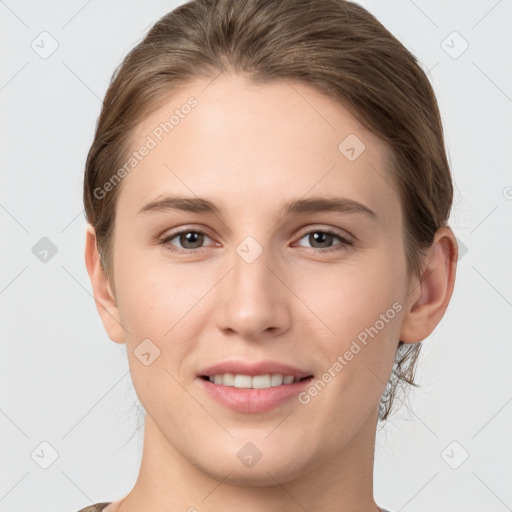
[119,75,399,224]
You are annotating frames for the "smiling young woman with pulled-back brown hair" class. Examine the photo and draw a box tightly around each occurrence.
[82,0,457,512]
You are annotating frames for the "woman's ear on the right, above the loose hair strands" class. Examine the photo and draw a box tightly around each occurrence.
[400,227,458,343]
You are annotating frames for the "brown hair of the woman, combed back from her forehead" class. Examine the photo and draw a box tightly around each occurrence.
[83,0,453,421]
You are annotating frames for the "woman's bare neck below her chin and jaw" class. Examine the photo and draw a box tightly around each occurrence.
[115,413,379,512]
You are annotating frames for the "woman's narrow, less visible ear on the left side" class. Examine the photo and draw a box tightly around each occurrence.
[85,224,124,343]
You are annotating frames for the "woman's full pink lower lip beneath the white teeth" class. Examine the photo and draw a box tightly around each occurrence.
[199,377,313,414]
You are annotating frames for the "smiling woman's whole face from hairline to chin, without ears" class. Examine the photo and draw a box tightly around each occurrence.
[104,75,407,485]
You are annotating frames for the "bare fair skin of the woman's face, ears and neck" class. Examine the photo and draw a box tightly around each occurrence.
[86,73,457,512]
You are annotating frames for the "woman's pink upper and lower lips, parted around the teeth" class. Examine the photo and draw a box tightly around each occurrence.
[196,361,313,414]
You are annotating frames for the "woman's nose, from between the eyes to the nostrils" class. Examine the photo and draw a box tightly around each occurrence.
[216,242,291,341]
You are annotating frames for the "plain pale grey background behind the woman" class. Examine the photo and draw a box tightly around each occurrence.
[0,0,512,512]
